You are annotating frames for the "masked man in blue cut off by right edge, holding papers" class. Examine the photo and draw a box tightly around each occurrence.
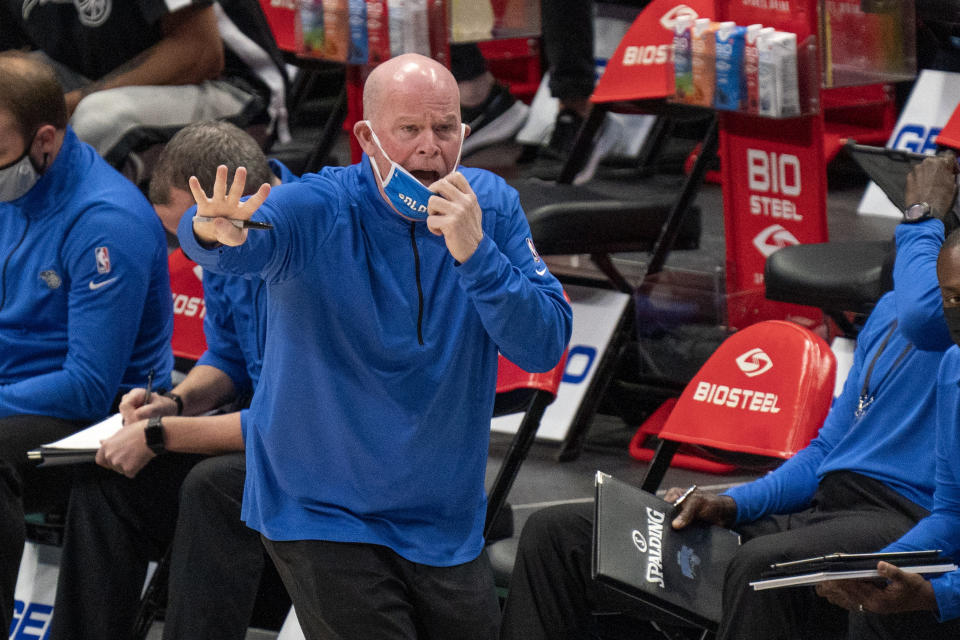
[817,231,960,640]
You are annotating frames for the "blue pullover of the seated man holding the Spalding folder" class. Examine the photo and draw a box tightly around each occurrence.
[726,220,952,522]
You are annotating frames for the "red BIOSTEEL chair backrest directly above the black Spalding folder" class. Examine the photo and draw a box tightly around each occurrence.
[660,320,836,459]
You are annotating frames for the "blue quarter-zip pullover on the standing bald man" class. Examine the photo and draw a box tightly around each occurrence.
[179,157,571,566]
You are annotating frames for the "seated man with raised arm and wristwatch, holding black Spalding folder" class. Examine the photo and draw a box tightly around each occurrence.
[501,153,956,640]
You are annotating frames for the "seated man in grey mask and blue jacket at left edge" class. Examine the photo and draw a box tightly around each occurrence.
[0,53,173,629]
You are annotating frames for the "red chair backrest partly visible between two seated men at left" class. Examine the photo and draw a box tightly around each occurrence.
[167,249,207,362]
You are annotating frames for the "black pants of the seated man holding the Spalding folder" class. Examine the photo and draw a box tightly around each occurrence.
[500,472,927,640]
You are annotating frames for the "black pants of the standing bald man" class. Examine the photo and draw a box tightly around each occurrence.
[262,538,500,640]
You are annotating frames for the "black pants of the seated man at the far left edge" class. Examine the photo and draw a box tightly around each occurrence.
[0,416,87,629]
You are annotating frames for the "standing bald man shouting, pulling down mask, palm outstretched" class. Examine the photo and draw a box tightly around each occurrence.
[179,54,571,640]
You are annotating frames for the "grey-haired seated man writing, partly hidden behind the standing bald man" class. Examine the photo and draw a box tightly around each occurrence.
[50,121,296,640]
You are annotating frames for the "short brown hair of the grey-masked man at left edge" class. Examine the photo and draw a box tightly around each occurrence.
[0,51,67,140]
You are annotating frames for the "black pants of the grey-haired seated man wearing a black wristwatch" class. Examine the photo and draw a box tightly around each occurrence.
[50,453,278,640]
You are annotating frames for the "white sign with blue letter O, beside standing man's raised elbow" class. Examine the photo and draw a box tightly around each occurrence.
[490,285,630,441]
